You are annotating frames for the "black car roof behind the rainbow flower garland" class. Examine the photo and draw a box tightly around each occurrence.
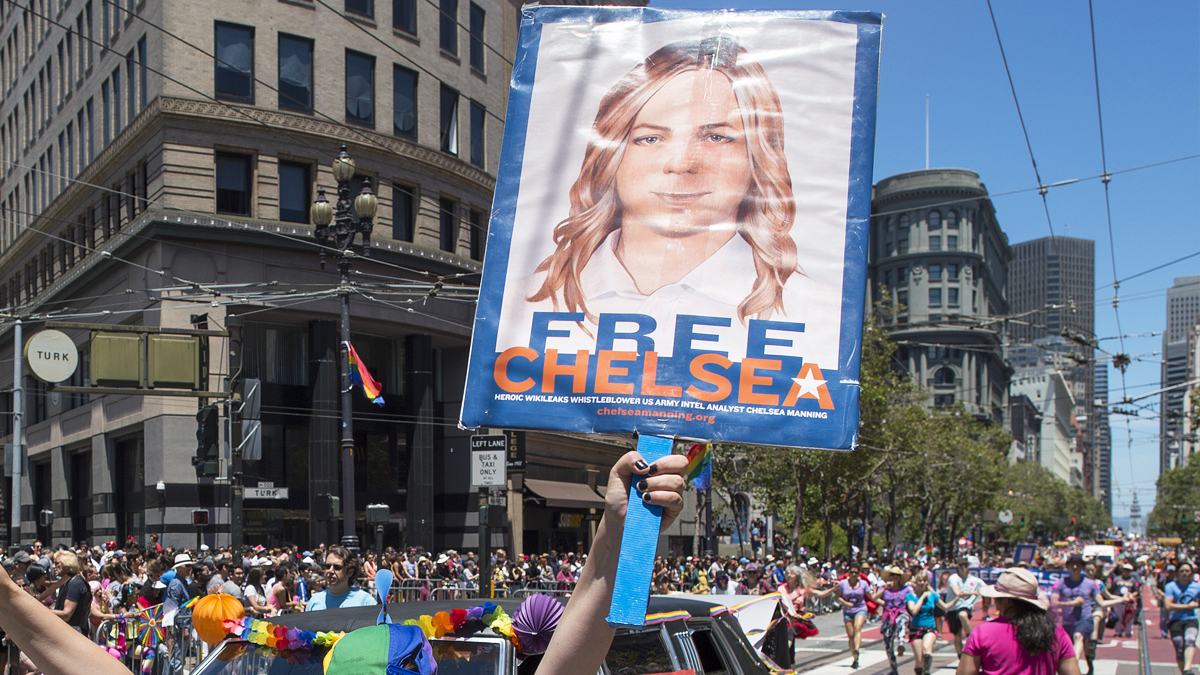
[266,596,720,637]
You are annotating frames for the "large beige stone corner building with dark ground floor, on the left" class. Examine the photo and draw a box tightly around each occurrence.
[0,0,667,551]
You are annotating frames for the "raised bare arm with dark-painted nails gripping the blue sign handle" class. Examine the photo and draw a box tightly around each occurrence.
[538,452,688,675]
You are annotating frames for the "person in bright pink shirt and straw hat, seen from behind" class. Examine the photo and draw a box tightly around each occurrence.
[956,567,1079,675]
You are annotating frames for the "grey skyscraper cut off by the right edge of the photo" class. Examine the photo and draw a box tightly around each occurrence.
[1158,276,1200,473]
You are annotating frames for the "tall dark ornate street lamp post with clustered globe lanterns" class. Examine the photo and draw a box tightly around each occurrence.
[312,145,378,550]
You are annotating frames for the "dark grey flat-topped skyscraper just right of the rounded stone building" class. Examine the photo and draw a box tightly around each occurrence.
[1008,237,1111,503]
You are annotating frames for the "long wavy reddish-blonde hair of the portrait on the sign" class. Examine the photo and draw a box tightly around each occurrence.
[528,37,800,323]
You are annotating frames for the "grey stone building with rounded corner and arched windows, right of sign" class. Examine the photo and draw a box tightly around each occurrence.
[868,169,1013,424]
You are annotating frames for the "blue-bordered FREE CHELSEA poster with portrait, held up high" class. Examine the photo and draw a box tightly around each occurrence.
[461,7,882,449]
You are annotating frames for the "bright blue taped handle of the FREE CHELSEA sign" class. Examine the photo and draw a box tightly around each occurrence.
[607,436,674,628]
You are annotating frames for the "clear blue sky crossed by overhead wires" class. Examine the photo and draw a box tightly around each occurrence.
[650,0,1200,516]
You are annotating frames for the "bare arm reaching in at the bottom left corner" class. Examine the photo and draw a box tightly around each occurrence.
[0,568,130,675]
